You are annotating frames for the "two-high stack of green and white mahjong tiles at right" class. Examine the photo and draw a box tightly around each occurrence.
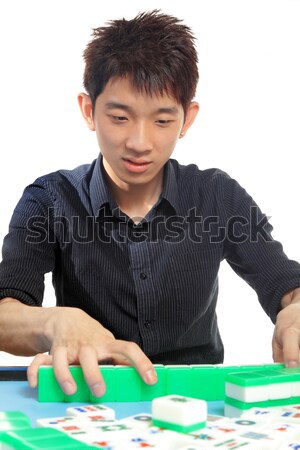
[225,368,300,417]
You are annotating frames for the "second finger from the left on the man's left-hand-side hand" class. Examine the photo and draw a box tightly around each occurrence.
[52,347,77,395]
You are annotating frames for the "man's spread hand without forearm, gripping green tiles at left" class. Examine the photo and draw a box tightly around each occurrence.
[27,308,157,397]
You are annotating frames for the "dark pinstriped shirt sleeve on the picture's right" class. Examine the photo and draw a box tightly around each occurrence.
[216,173,300,323]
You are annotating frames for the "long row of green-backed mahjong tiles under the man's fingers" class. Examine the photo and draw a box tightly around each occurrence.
[38,364,300,403]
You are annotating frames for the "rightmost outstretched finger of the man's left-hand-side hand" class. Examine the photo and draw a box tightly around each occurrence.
[112,340,157,384]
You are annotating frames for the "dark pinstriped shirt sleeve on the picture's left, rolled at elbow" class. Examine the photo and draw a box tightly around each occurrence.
[0,182,56,306]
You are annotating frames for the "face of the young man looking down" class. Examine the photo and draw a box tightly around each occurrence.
[86,78,184,186]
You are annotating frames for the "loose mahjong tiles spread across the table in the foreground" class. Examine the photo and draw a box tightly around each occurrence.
[0,395,300,450]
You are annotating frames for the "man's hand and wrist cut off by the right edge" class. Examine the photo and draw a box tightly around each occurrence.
[272,288,300,367]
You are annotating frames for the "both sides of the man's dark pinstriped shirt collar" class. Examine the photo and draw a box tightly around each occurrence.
[90,153,178,217]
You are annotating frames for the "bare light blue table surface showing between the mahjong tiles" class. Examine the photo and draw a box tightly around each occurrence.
[0,371,224,427]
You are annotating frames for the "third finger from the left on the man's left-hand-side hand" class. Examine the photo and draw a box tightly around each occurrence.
[79,345,106,397]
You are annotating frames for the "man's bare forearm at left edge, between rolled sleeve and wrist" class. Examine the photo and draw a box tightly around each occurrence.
[0,298,53,356]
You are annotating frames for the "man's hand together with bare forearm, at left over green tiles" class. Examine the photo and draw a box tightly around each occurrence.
[0,299,157,397]
